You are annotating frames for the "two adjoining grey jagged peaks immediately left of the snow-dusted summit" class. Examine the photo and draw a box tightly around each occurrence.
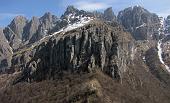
[28,12,59,43]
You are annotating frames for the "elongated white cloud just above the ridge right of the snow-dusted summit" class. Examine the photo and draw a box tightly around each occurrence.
[74,1,110,11]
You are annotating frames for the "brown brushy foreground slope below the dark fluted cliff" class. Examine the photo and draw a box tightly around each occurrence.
[0,66,170,103]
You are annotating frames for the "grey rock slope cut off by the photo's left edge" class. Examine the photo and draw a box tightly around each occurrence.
[0,29,13,72]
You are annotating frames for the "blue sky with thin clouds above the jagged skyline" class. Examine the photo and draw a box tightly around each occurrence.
[0,0,170,27]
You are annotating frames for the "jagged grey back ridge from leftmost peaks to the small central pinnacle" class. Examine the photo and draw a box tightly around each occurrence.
[3,6,115,50]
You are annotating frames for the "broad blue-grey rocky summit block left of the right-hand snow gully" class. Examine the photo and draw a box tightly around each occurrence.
[118,6,160,40]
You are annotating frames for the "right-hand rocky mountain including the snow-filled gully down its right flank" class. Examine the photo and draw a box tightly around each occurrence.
[118,6,170,85]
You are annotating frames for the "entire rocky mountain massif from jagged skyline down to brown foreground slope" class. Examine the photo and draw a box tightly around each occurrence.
[0,6,170,103]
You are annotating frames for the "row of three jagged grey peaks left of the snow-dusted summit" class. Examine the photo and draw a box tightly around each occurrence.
[4,13,58,50]
